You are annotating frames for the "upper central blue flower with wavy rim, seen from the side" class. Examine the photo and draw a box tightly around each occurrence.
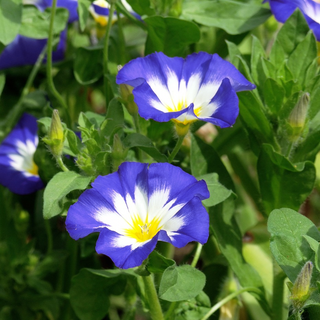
[117,52,255,128]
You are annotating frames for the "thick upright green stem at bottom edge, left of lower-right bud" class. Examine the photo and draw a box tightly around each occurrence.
[272,260,286,320]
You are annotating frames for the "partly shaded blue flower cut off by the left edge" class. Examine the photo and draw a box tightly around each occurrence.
[0,113,44,194]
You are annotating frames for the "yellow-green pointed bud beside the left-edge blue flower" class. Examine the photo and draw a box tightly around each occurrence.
[42,110,64,157]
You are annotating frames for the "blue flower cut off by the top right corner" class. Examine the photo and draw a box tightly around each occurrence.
[264,0,320,41]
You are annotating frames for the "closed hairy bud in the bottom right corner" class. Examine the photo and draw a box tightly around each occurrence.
[290,261,313,309]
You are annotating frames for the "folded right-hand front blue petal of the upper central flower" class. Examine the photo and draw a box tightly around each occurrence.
[198,78,239,128]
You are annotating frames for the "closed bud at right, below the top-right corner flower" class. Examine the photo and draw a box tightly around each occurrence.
[288,92,310,141]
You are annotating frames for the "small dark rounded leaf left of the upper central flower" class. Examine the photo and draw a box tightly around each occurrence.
[73,47,103,85]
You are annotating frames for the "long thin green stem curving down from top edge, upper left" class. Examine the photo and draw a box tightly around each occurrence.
[47,0,70,122]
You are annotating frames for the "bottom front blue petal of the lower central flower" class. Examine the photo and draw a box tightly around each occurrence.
[96,229,158,269]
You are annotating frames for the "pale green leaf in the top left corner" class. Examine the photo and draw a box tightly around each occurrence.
[0,0,22,45]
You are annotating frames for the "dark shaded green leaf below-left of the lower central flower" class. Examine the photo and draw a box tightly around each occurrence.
[70,269,129,320]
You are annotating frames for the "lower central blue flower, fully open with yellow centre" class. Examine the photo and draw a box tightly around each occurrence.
[66,162,209,269]
